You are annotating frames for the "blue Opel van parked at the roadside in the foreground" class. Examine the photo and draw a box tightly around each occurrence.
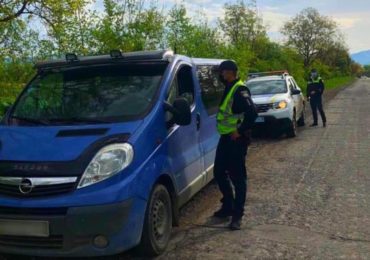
[0,51,224,257]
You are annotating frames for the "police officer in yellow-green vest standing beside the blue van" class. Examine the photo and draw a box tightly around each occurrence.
[214,60,257,230]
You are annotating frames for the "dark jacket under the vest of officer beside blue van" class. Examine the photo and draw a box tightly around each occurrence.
[220,79,258,135]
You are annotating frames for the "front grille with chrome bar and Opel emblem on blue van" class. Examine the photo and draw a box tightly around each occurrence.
[0,177,77,198]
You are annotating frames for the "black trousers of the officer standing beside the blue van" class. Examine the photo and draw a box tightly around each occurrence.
[214,135,248,217]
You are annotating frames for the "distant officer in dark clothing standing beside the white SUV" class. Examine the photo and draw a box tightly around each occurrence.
[306,69,326,127]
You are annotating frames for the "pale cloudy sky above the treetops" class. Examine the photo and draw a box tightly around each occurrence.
[155,0,370,53]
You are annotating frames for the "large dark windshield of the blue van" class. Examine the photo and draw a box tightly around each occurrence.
[9,63,167,125]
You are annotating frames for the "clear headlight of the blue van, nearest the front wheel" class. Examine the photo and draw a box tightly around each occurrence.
[78,143,134,188]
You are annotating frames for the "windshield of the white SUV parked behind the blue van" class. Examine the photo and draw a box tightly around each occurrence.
[247,80,288,95]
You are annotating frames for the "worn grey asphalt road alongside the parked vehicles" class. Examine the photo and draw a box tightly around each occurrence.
[0,80,370,260]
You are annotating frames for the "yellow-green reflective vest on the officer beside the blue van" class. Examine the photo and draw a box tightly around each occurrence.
[217,80,244,135]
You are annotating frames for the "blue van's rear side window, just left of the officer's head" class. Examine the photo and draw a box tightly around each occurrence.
[197,65,225,115]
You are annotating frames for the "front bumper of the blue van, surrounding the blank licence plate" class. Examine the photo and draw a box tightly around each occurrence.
[0,198,146,257]
